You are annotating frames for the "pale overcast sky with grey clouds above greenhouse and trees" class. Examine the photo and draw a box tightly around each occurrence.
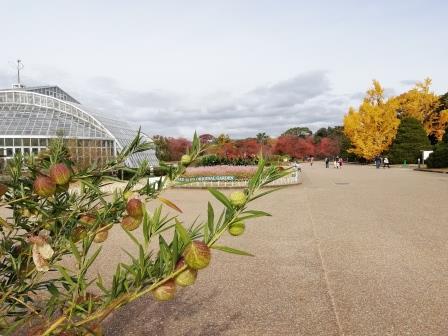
[0,0,448,137]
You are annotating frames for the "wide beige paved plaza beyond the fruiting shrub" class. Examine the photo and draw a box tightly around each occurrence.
[100,163,448,336]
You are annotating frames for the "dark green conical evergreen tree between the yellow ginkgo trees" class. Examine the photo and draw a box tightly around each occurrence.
[389,118,431,163]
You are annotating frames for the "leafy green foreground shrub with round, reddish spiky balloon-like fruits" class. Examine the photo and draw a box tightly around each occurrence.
[0,134,289,335]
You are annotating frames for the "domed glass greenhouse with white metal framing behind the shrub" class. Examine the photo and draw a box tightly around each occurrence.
[0,86,159,168]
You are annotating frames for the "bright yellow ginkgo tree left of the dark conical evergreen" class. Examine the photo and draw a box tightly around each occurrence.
[344,80,400,160]
